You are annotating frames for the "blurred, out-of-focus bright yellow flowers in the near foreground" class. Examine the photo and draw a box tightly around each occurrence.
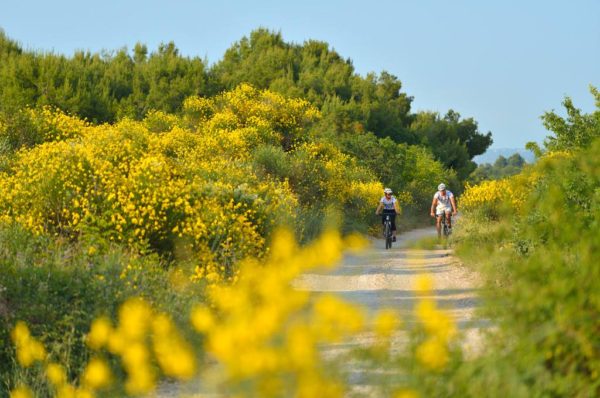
[12,225,456,398]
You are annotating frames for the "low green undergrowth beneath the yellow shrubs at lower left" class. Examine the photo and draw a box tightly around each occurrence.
[0,225,202,396]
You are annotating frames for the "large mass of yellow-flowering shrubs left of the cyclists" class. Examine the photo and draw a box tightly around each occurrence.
[0,85,381,281]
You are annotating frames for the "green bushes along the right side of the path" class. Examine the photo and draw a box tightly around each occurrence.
[453,85,600,397]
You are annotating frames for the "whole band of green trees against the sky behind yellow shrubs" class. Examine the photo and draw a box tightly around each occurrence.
[0,29,491,188]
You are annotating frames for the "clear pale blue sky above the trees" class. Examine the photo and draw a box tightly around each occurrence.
[0,0,600,148]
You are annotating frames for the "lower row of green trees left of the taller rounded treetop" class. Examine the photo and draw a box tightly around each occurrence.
[0,32,207,123]
